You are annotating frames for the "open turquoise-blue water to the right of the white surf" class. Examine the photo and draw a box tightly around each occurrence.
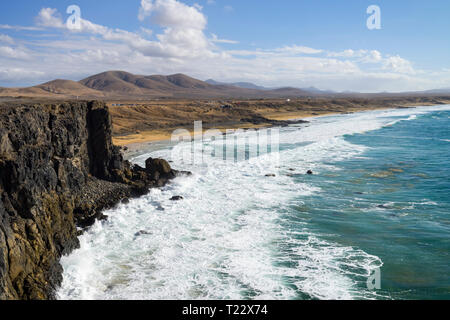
[293,111,450,299]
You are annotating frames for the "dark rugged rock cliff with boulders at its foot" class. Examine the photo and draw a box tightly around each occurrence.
[0,101,185,299]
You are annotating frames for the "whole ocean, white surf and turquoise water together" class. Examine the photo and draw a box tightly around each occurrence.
[57,105,450,300]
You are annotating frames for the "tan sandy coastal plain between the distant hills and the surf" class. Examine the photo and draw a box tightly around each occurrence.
[109,97,450,149]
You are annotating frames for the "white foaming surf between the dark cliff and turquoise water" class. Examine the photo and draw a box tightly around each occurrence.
[58,108,450,299]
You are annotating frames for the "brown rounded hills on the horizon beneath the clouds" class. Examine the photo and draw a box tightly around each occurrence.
[0,71,320,99]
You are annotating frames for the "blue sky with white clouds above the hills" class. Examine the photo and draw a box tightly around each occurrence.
[0,0,450,92]
